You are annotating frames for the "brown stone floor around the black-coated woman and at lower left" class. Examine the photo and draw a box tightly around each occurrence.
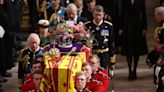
[2,0,159,92]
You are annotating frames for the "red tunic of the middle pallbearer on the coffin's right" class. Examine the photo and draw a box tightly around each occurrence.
[82,78,106,92]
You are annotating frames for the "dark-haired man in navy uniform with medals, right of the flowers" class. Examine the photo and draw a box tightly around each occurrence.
[84,5,116,69]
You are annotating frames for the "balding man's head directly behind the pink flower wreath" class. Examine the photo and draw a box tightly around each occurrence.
[65,3,87,24]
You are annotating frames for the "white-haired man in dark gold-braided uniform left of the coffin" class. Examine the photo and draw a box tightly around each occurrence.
[18,33,43,88]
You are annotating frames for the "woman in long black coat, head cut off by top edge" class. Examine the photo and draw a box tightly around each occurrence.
[119,0,148,80]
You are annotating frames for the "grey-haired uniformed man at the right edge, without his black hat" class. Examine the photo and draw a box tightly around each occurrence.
[153,6,164,92]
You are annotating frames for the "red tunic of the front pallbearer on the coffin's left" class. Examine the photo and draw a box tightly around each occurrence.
[21,79,40,92]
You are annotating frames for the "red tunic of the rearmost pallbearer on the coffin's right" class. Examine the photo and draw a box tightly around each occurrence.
[92,68,110,92]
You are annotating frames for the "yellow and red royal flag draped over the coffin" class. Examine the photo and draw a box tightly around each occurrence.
[41,52,86,92]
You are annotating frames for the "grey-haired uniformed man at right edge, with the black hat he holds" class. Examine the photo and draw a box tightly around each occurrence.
[152,6,164,84]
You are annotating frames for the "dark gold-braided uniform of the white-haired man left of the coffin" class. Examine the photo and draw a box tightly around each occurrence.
[18,48,43,84]
